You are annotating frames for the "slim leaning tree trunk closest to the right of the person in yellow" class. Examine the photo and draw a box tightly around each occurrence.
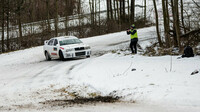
[153,0,163,47]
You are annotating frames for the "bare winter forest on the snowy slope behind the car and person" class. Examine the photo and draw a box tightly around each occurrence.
[0,0,200,53]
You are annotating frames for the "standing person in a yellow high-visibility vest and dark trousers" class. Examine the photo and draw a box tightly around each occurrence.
[127,24,138,54]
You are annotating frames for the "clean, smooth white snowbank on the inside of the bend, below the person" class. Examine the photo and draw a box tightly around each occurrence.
[71,54,200,106]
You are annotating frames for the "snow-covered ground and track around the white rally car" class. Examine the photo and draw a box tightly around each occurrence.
[0,27,200,112]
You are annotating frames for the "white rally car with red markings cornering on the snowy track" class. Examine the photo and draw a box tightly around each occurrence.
[44,36,91,60]
